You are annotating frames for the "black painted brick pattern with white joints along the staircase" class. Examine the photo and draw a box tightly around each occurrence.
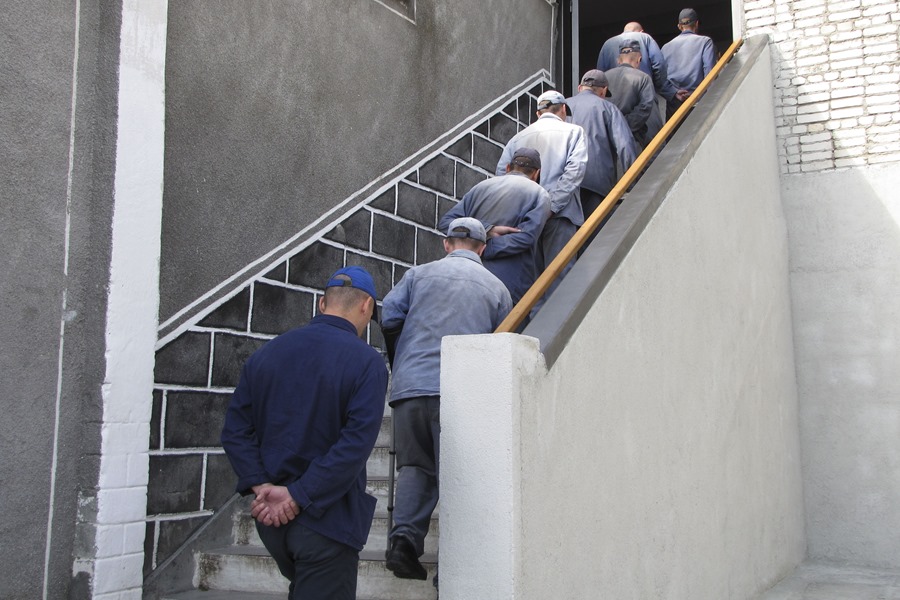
[144,82,549,574]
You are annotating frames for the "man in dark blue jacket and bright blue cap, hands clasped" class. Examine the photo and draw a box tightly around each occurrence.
[222,267,388,600]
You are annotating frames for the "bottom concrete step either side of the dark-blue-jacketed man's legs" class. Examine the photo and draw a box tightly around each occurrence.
[197,545,437,600]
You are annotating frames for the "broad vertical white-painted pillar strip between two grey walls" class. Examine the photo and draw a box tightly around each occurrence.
[88,0,168,597]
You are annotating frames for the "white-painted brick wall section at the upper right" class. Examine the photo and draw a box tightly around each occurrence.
[744,0,900,173]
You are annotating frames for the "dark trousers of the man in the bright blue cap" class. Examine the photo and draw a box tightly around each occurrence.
[256,519,359,600]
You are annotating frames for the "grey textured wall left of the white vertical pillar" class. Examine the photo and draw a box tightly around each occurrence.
[0,0,120,599]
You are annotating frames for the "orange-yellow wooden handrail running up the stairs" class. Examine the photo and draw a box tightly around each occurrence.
[494,39,744,333]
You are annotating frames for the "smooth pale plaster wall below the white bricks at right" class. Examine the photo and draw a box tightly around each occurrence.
[782,164,900,569]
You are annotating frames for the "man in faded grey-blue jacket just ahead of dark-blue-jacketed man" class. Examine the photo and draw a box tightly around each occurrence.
[382,217,512,580]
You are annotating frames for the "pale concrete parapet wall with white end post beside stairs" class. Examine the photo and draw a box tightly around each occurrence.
[441,43,805,600]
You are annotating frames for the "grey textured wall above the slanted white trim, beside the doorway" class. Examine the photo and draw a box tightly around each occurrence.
[160,0,551,321]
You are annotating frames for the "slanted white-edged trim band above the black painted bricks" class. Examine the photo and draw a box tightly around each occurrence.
[156,69,550,350]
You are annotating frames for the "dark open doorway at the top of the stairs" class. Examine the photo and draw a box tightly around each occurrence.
[561,0,737,94]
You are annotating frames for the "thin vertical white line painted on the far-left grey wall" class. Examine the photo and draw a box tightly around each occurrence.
[41,0,81,600]
